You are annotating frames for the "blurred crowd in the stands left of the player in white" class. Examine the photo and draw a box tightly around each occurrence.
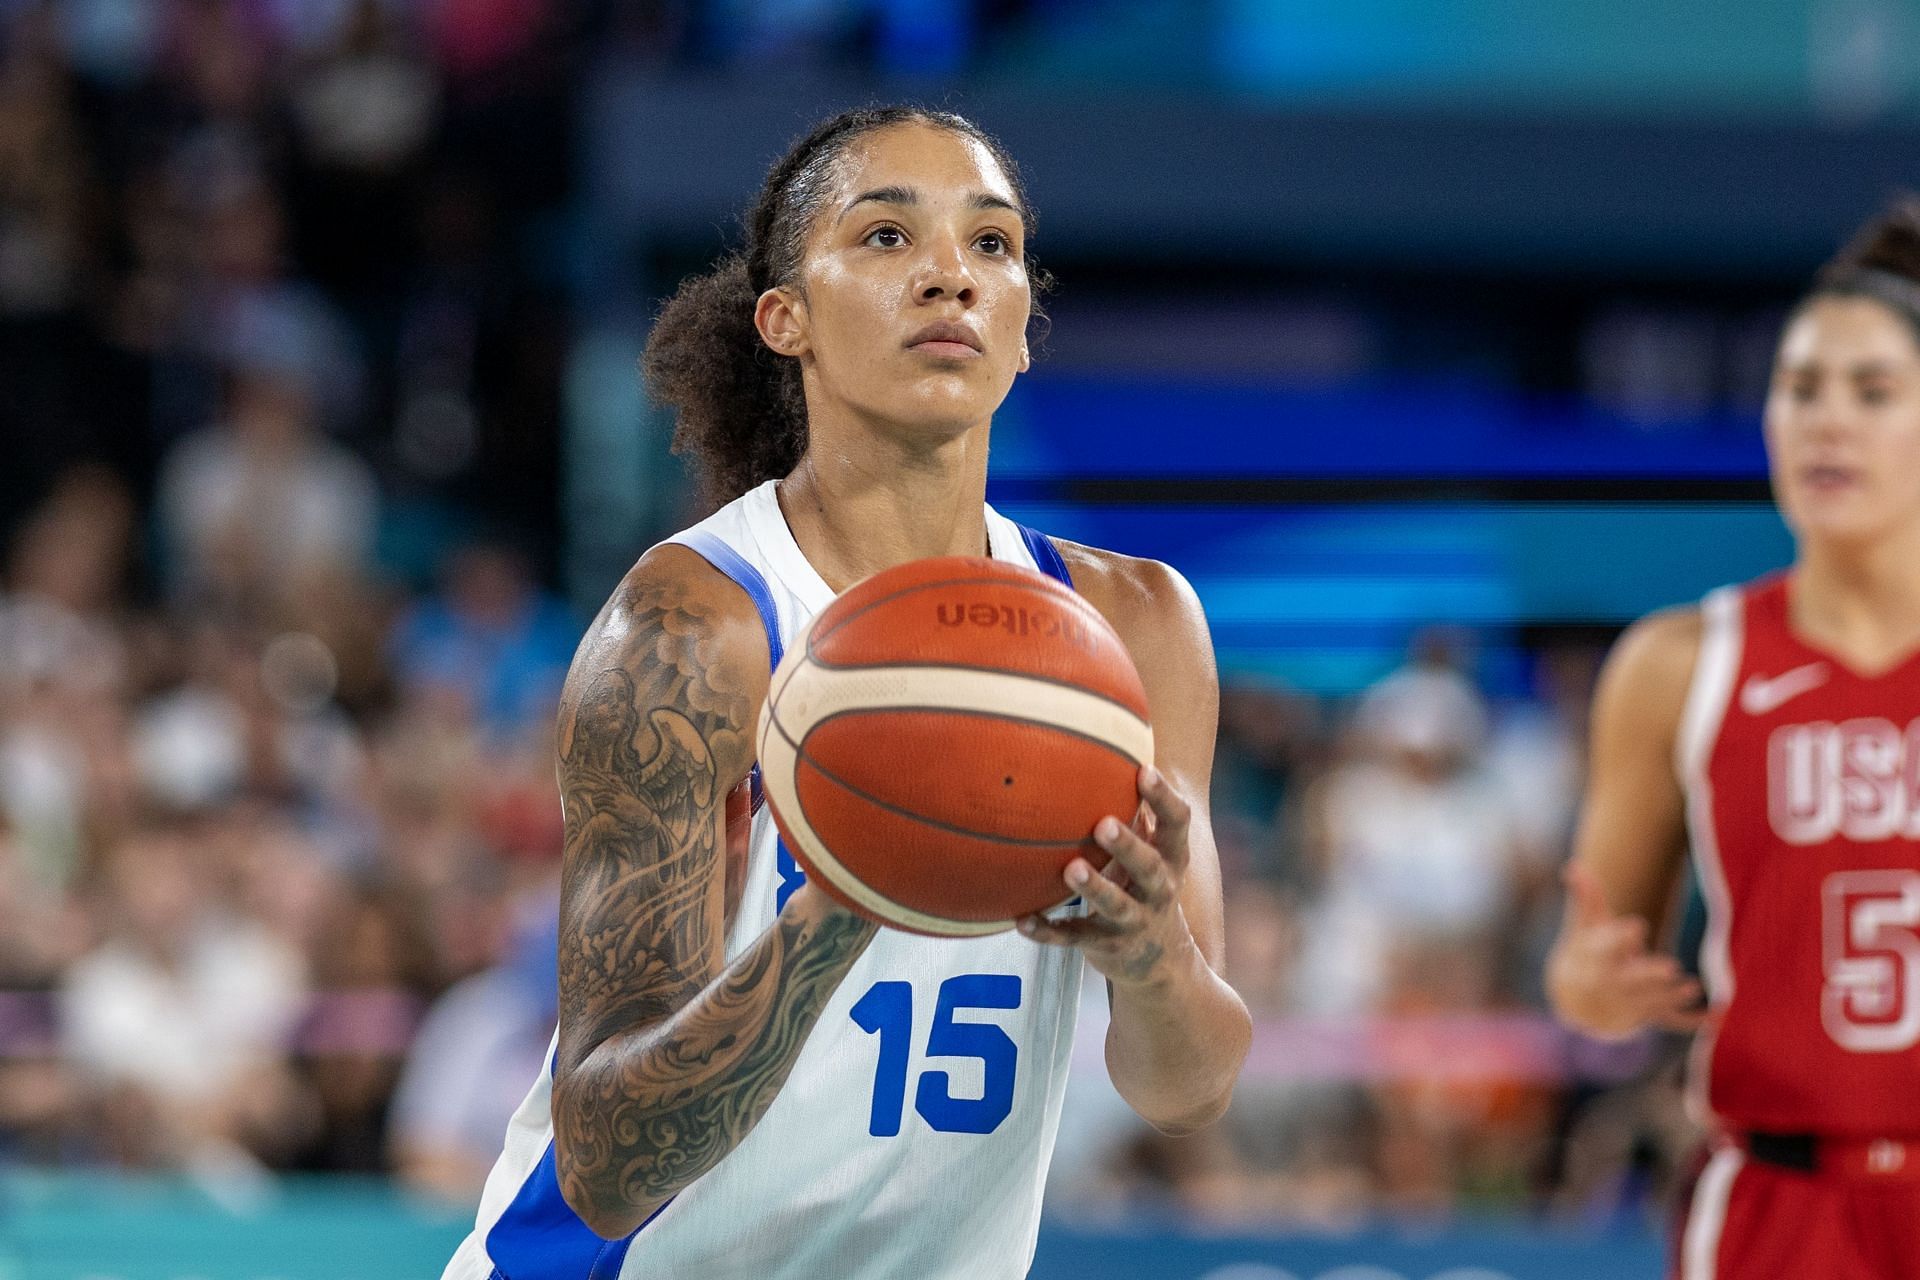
[0,0,605,1197]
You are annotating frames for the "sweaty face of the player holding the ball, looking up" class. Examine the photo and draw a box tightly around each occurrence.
[760,123,1033,438]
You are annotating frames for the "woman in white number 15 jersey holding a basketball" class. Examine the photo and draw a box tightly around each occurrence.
[447,107,1250,1280]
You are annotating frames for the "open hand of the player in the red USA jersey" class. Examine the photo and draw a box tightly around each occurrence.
[1548,862,1707,1040]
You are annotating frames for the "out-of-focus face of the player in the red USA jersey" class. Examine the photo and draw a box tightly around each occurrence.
[1766,297,1920,543]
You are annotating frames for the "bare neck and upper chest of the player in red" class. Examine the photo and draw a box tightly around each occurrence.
[1791,522,1920,670]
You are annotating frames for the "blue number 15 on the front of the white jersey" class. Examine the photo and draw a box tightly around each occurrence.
[852,973,1020,1138]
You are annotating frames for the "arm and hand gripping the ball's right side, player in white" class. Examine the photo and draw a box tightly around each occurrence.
[1029,545,1252,1132]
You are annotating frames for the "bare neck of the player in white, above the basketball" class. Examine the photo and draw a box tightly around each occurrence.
[780,422,987,591]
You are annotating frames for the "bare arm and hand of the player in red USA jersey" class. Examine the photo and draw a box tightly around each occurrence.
[1548,610,1699,1038]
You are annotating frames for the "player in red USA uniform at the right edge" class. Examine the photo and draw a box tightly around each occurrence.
[1548,201,1920,1280]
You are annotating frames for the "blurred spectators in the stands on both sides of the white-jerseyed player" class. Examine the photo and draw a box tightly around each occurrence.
[0,0,1712,1243]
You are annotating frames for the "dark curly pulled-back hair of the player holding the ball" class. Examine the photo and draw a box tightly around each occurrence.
[639,106,1050,505]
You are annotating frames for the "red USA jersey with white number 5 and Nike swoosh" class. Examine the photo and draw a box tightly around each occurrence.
[1678,576,1920,1136]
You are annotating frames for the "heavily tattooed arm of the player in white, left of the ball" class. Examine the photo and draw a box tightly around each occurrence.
[553,545,874,1238]
